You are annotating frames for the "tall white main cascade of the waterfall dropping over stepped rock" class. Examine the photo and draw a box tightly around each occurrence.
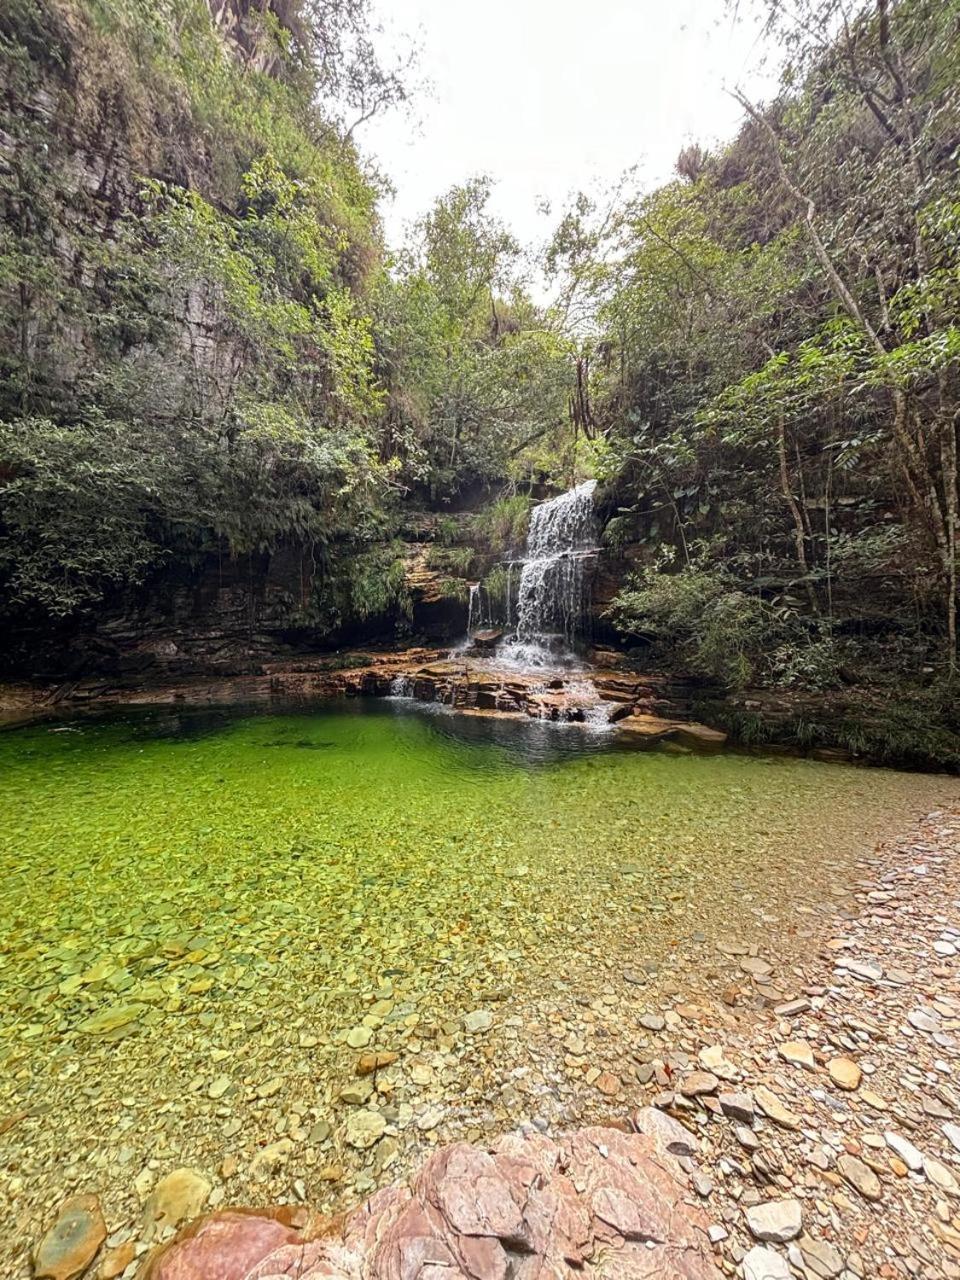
[500,480,596,666]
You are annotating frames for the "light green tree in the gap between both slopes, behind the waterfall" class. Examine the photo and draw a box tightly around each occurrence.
[378,179,572,502]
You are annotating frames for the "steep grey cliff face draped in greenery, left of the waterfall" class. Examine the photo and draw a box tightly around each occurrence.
[0,0,396,660]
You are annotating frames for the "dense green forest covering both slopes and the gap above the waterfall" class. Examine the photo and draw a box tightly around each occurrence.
[0,0,960,755]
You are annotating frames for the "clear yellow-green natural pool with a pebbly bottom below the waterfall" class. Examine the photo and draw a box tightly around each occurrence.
[0,701,957,1274]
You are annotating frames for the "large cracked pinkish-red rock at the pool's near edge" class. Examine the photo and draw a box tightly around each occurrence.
[143,1129,719,1280]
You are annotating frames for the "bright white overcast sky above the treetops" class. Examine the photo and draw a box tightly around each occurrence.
[357,0,773,254]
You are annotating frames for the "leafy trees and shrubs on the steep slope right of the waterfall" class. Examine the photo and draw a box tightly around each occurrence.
[550,0,960,682]
